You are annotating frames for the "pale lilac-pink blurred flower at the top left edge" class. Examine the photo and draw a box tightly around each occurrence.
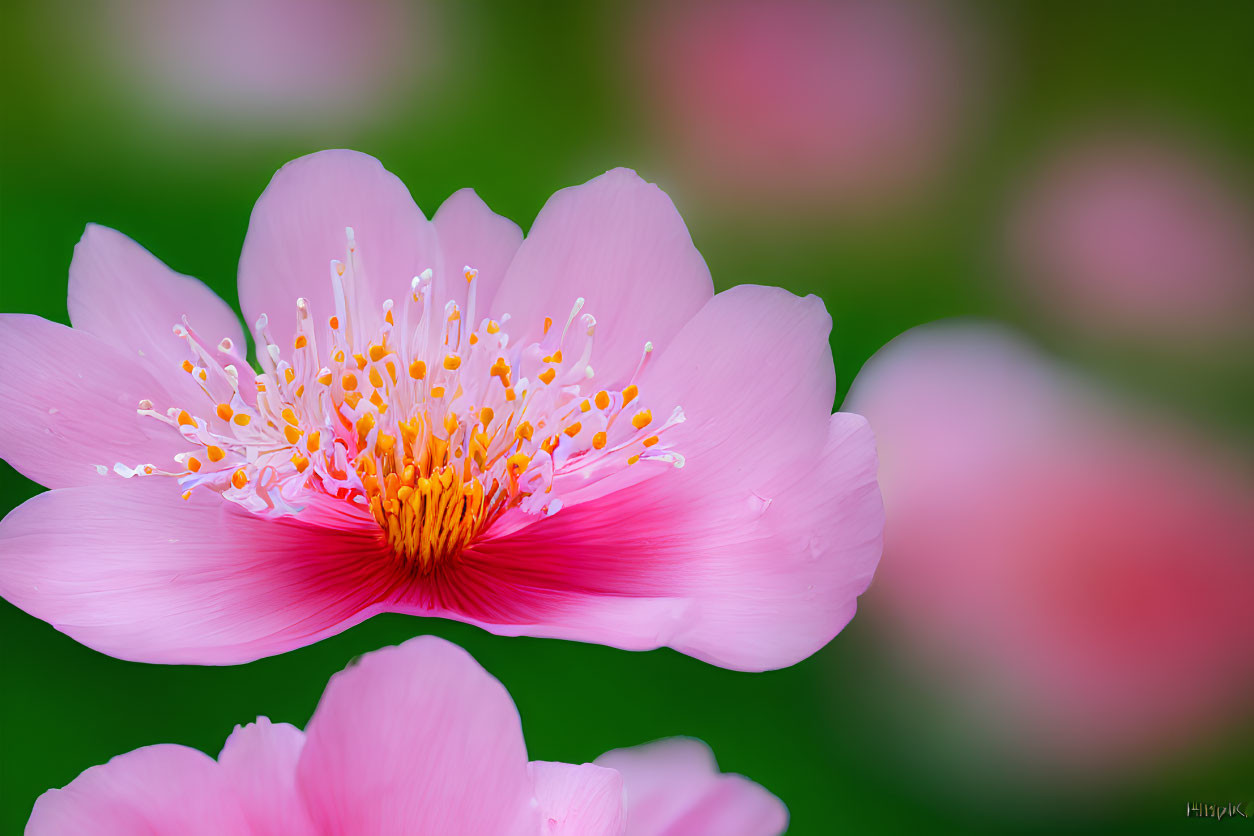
[88,0,439,133]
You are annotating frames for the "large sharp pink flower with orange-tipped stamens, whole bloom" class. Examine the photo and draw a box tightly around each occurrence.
[0,150,883,669]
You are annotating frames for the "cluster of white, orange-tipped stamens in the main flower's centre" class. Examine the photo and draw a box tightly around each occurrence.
[118,228,683,573]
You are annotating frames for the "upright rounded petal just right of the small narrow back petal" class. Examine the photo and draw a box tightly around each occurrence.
[492,168,714,386]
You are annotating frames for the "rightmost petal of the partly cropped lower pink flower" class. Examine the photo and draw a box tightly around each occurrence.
[597,737,788,836]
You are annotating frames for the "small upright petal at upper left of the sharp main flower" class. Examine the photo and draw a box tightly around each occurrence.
[69,223,248,402]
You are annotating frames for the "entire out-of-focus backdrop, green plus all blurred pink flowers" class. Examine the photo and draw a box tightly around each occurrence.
[0,0,1254,833]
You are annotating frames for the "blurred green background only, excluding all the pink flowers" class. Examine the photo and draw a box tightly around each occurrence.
[0,0,1254,833]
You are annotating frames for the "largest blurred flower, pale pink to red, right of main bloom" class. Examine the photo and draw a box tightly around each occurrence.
[848,325,1254,766]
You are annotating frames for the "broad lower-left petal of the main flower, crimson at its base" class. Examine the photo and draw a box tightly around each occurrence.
[0,478,385,664]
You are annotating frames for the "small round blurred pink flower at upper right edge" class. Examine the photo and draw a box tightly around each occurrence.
[1009,134,1254,338]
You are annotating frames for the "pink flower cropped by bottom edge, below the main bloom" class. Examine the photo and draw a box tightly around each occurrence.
[26,635,788,836]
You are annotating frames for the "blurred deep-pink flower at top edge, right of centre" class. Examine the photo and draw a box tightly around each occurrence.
[637,0,969,212]
